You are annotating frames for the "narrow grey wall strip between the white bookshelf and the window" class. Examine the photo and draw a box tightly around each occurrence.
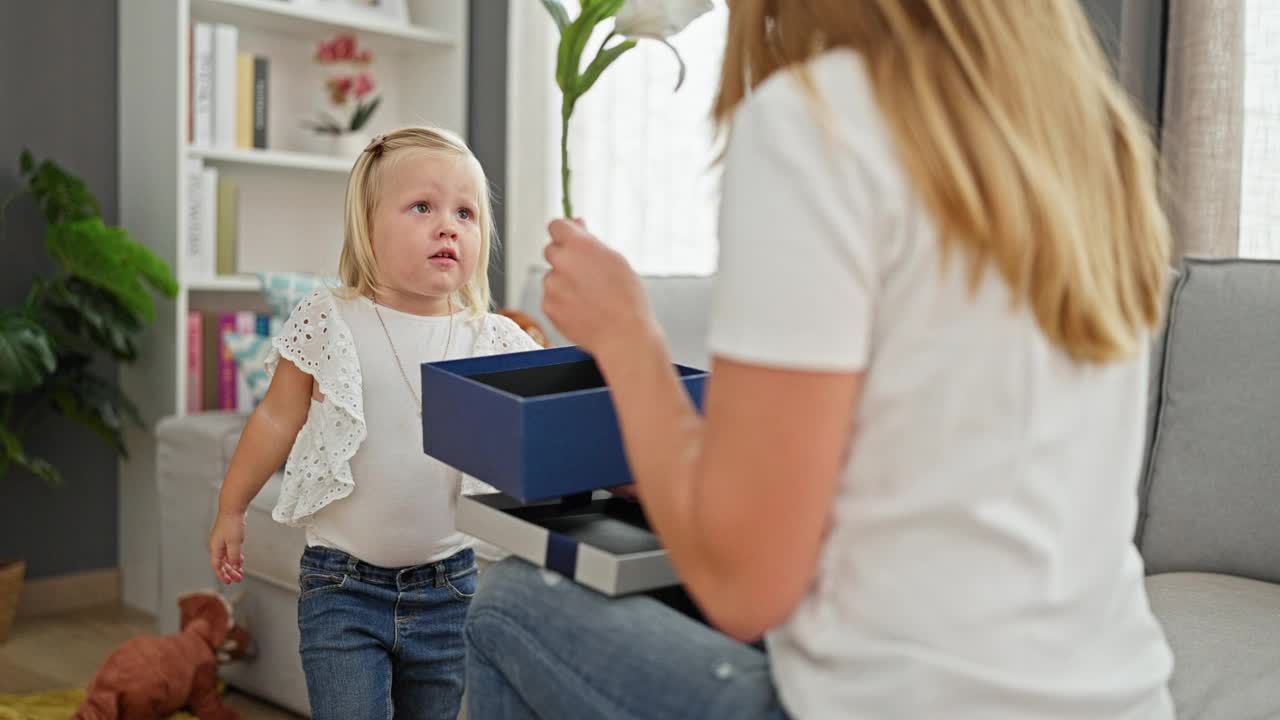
[467,0,509,307]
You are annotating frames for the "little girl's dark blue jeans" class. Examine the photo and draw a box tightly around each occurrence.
[298,547,476,720]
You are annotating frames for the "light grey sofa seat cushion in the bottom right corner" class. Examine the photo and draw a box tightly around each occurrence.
[1147,573,1280,720]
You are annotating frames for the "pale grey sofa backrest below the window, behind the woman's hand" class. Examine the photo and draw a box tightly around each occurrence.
[520,266,712,369]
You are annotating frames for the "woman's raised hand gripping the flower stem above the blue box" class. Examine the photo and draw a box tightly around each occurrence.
[543,220,660,357]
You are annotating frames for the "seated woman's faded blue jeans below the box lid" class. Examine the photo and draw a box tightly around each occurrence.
[466,559,786,720]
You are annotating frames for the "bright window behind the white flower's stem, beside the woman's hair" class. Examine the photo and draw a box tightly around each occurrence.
[560,0,728,274]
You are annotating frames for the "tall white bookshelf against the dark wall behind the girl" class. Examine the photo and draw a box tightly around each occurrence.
[118,0,468,612]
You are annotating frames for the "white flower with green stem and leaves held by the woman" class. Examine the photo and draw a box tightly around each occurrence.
[541,0,712,218]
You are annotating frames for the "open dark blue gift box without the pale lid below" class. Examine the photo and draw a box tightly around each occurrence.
[422,347,707,502]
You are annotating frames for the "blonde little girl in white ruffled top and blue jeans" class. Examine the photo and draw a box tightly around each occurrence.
[209,128,538,720]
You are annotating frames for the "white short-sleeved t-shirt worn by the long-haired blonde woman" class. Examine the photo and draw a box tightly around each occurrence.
[710,51,1172,720]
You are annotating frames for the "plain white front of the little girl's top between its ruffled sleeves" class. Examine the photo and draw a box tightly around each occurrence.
[307,296,476,568]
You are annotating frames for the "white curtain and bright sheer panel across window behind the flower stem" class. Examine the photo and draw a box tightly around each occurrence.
[506,0,728,300]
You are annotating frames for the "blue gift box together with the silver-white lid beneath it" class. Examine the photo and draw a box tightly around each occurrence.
[422,347,707,594]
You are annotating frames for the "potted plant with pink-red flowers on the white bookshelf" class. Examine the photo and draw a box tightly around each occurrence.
[306,33,381,158]
